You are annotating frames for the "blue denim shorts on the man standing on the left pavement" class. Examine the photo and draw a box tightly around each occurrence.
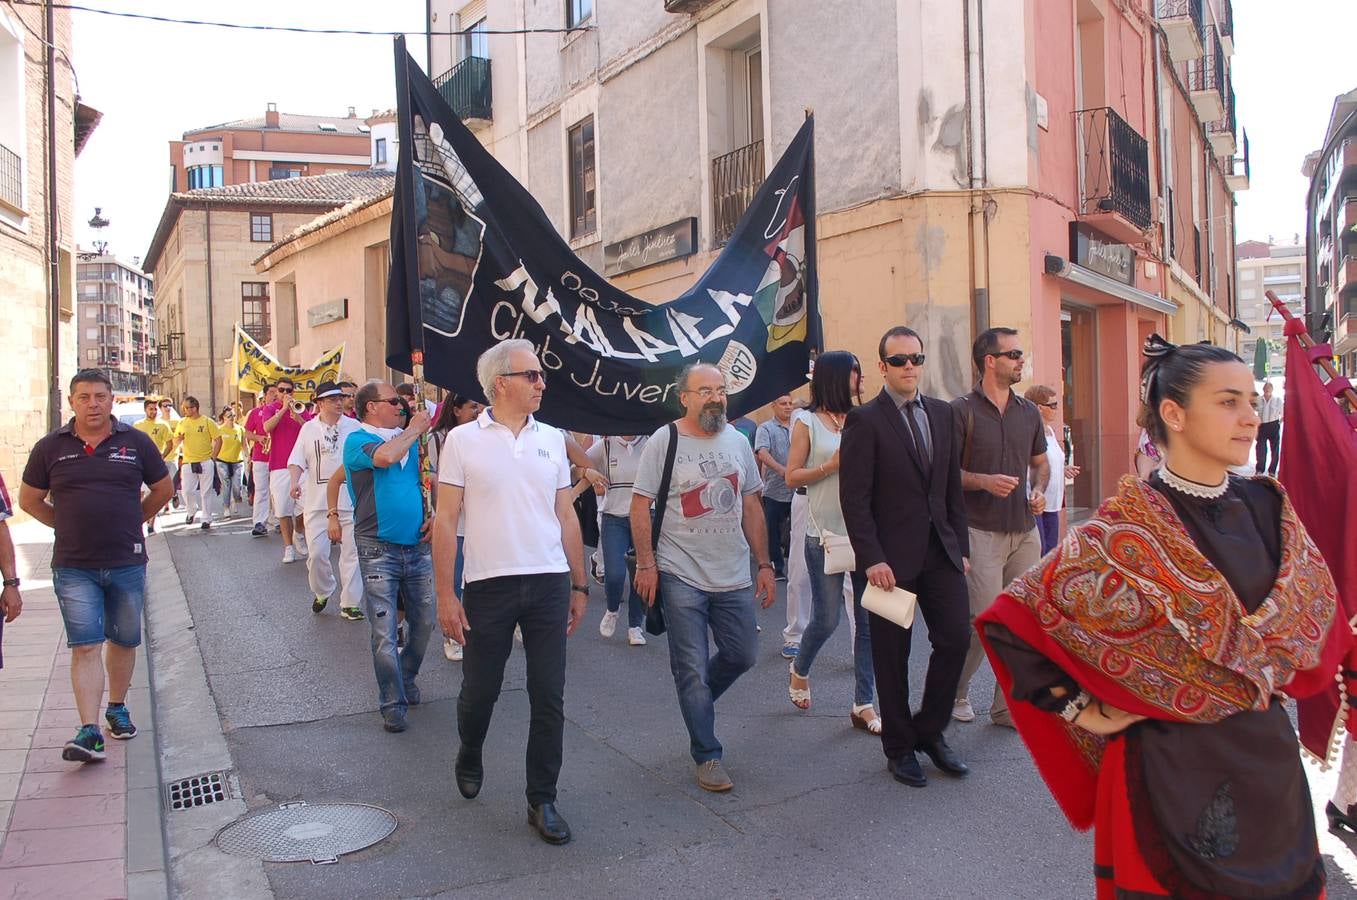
[52,565,147,648]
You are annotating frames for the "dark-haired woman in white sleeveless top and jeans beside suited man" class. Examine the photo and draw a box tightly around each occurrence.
[787,350,881,734]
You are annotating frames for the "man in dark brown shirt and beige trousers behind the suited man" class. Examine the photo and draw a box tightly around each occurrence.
[951,327,1050,728]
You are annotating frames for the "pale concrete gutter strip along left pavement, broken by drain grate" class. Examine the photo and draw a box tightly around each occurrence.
[144,535,273,899]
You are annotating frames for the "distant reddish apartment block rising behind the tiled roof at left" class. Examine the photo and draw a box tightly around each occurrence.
[170,103,370,191]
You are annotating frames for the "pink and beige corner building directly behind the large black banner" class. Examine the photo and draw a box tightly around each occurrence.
[427,0,1247,506]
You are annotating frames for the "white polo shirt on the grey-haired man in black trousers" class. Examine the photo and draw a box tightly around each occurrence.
[438,409,570,584]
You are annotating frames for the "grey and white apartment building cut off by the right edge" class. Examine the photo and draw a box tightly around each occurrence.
[1301,88,1357,377]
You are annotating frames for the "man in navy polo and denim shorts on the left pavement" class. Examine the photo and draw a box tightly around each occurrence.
[19,369,174,763]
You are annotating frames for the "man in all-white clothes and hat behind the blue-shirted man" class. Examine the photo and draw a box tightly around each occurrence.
[288,381,362,622]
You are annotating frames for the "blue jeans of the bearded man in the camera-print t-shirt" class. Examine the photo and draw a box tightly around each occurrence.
[660,571,757,764]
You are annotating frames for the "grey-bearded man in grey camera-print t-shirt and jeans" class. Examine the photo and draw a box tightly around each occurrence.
[631,362,776,791]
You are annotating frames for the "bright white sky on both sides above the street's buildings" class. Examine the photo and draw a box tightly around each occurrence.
[72,0,1357,264]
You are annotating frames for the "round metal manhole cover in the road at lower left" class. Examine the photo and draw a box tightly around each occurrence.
[217,801,396,862]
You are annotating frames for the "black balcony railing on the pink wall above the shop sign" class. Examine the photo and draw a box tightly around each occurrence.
[1075,106,1151,231]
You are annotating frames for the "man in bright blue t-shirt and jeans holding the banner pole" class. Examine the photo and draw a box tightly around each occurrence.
[326,381,434,732]
